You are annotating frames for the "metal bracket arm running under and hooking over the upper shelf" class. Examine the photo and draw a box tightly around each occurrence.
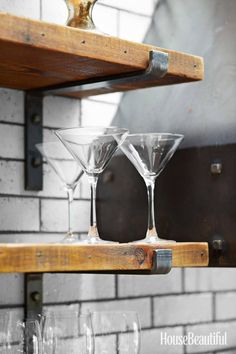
[43,50,169,97]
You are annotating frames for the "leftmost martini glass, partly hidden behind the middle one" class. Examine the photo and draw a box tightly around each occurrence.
[36,141,83,243]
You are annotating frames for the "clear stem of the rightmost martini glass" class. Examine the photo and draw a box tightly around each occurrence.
[145,179,158,239]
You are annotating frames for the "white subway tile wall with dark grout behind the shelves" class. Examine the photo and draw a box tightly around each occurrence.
[0,0,236,354]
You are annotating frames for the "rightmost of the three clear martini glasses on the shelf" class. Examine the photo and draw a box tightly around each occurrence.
[117,133,183,243]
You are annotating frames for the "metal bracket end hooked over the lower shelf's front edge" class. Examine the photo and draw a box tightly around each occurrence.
[152,249,173,274]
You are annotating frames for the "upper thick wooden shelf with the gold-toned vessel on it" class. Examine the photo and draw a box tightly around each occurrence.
[0,13,204,97]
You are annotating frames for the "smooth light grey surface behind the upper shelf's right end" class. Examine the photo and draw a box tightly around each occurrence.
[113,0,236,148]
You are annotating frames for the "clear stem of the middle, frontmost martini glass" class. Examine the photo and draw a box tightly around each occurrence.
[88,176,99,239]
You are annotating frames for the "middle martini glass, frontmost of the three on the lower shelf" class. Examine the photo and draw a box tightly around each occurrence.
[55,127,128,244]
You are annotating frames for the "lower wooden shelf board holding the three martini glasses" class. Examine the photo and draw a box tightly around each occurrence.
[0,243,209,273]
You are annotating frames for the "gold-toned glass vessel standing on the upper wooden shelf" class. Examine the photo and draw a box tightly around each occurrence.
[66,0,97,31]
